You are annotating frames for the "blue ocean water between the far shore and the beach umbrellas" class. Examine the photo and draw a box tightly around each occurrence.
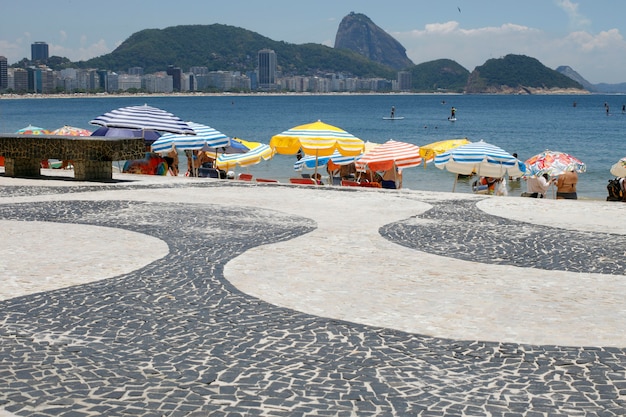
[0,94,626,199]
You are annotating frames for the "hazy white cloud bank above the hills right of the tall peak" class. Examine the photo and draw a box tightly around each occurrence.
[392,21,626,83]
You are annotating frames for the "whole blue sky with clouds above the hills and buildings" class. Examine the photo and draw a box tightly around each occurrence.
[0,0,626,83]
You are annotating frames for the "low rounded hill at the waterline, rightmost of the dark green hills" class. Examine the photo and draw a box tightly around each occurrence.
[465,54,583,94]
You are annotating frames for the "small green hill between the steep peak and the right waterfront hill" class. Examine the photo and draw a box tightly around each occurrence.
[408,59,470,93]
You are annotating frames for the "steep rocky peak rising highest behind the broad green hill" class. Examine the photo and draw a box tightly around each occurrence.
[335,12,414,70]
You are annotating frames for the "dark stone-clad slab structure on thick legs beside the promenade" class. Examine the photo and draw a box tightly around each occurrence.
[0,135,145,181]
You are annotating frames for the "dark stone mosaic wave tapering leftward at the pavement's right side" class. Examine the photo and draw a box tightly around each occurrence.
[380,200,626,275]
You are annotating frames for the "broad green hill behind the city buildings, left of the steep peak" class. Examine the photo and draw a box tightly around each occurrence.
[77,24,395,78]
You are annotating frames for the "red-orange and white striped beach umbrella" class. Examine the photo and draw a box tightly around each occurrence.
[356,139,422,172]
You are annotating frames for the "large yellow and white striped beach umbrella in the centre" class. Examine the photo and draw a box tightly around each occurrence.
[270,120,365,157]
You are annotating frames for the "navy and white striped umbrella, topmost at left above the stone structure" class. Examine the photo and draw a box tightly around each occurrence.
[89,104,195,135]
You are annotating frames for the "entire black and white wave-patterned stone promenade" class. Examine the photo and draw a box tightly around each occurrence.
[0,171,626,417]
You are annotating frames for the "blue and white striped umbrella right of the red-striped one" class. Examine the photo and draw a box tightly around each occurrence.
[435,140,526,178]
